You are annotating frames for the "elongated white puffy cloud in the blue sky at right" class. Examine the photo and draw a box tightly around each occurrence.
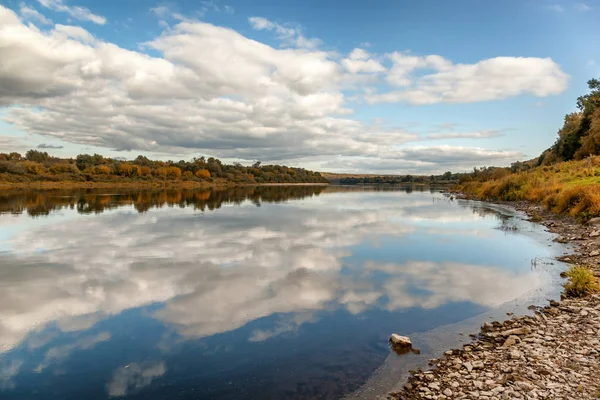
[366,53,569,105]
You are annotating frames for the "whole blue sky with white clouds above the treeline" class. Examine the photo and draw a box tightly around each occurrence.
[0,0,600,175]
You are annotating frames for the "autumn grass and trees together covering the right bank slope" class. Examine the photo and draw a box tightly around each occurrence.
[454,79,600,222]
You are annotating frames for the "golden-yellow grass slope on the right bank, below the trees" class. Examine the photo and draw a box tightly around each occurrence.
[456,156,600,222]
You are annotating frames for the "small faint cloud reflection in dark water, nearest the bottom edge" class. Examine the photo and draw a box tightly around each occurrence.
[106,361,167,397]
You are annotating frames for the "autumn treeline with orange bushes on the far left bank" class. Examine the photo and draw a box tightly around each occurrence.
[0,150,328,184]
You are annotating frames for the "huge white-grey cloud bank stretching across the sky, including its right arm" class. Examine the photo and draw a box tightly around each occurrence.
[0,4,568,173]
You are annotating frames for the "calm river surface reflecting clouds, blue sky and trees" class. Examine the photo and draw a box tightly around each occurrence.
[0,186,561,400]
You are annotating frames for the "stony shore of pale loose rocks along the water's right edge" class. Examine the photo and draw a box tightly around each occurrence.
[387,202,600,400]
